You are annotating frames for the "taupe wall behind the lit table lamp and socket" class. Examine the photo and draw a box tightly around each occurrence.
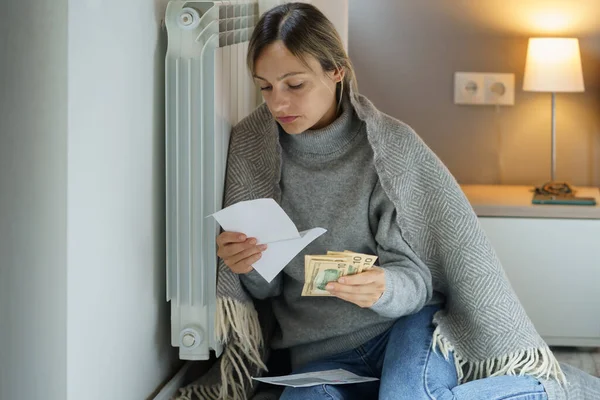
[349,0,600,186]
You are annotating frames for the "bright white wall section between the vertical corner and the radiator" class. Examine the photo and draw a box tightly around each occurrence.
[67,0,177,400]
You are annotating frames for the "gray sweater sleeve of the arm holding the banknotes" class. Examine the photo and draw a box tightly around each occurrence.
[369,182,433,318]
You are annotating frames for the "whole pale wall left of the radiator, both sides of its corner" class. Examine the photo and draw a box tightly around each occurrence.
[0,0,177,400]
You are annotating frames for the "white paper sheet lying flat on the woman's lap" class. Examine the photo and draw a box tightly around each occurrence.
[252,369,379,387]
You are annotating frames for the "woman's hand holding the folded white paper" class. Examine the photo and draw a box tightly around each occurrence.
[217,232,267,274]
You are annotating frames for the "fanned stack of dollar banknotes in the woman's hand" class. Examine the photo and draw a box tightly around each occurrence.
[302,250,377,296]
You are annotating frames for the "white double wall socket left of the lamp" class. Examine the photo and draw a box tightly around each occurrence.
[454,72,515,106]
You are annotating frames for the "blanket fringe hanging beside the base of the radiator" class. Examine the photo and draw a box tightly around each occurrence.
[173,298,267,400]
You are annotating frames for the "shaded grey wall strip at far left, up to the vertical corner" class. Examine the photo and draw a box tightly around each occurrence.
[0,0,67,400]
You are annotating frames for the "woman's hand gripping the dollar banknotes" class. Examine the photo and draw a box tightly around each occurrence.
[325,267,385,308]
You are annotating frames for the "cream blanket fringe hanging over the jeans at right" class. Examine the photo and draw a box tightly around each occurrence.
[432,326,567,385]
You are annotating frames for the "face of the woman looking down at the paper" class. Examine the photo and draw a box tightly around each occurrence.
[254,41,343,134]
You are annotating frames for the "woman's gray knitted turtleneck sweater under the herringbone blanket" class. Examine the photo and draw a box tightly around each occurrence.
[241,102,439,368]
